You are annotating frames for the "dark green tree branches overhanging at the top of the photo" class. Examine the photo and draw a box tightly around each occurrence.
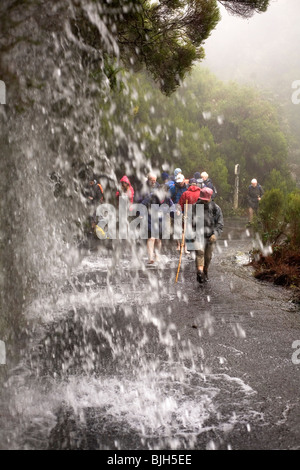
[72,0,268,95]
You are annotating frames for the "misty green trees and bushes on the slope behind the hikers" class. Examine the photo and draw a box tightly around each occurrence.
[104,67,294,206]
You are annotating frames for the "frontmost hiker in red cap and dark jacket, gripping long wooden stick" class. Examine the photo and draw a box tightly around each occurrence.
[195,187,224,284]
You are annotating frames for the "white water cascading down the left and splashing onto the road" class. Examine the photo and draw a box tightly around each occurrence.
[0,0,276,449]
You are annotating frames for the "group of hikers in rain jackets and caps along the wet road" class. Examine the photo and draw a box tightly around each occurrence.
[84,168,263,283]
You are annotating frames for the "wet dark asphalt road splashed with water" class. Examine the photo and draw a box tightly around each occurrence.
[0,220,300,450]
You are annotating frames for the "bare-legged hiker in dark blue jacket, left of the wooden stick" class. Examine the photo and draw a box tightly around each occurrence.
[142,185,175,264]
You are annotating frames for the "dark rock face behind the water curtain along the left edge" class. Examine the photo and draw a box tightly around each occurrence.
[0,0,122,346]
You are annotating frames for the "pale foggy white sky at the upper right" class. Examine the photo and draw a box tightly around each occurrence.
[202,0,300,98]
